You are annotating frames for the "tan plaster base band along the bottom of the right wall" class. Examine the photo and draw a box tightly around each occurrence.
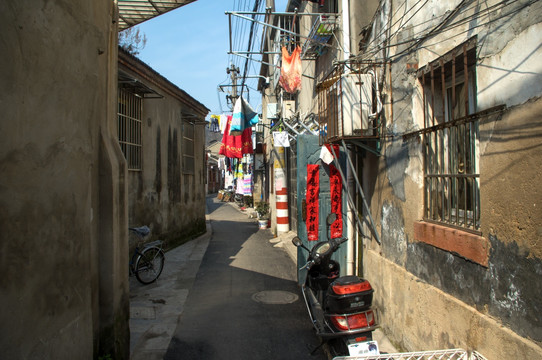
[364,250,542,359]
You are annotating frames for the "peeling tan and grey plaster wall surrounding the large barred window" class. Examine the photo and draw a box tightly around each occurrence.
[363,1,542,359]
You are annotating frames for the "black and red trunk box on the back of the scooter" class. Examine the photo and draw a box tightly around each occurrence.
[325,276,374,314]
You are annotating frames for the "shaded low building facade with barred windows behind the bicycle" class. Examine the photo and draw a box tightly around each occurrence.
[117,49,209,246]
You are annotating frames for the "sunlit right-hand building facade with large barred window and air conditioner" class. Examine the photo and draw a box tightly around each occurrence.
[261,0,542,359]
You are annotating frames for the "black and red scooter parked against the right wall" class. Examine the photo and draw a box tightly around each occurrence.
[292,214,380,356]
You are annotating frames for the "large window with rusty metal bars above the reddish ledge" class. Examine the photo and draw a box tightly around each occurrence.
[418,40,480,232]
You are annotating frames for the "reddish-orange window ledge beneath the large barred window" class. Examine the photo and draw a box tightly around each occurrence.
[414,221,489,267]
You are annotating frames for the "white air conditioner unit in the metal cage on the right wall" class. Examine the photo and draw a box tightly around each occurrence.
[339,74,373,136]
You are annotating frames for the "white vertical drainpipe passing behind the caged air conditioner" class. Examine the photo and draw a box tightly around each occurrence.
[341,0,357,275]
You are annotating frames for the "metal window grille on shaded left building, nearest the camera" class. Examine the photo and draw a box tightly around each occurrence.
[117,89,143,171]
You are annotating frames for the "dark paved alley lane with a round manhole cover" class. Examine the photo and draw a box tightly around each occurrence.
[164,199,326,360]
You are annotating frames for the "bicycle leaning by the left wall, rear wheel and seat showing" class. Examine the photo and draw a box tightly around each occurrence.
[128,226,165,285]
